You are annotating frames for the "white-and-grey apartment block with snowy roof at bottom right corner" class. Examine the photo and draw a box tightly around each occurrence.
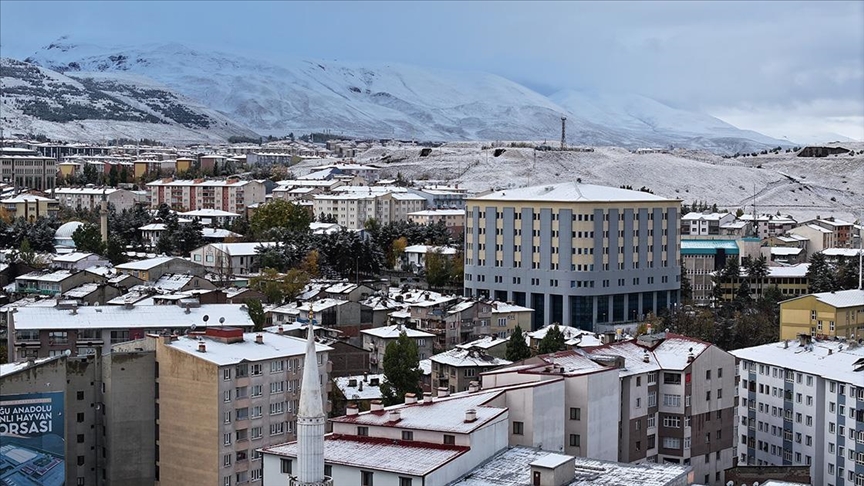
[732,334,864,486]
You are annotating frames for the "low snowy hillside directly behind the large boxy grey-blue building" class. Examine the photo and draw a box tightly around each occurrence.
[293,143,864,220]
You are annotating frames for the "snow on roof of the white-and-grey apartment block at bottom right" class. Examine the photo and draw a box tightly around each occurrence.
[730,340,864,386]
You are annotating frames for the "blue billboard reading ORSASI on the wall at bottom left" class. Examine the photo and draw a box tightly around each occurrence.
[0,392,66,486]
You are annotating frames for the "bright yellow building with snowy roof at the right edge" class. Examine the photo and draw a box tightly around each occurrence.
[780,290,864,339]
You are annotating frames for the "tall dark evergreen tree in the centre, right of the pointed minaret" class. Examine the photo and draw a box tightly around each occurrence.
[381,331,423,406]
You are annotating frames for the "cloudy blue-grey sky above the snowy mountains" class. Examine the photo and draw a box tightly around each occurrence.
[0,1,864,142]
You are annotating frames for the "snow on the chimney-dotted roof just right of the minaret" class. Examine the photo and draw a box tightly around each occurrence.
[331,390,507,434]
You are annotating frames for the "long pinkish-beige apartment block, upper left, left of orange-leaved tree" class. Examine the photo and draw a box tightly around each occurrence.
[147,178,266,214]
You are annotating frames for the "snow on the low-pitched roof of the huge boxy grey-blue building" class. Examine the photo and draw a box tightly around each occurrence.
[472,182,675,203]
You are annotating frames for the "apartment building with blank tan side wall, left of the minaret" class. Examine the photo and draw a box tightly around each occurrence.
[156,328,330,486]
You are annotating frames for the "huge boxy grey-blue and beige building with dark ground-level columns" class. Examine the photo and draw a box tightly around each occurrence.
[465,182,681,329]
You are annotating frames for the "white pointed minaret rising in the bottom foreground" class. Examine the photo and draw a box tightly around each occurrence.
[289,310,333,486]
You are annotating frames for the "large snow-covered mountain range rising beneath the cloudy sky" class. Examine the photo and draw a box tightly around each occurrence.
[15,38,788,152]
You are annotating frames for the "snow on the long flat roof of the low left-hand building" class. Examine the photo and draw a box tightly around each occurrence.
[13,304,252,330]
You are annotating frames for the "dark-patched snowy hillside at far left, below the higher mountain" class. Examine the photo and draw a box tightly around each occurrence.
[0,59,254,143]
